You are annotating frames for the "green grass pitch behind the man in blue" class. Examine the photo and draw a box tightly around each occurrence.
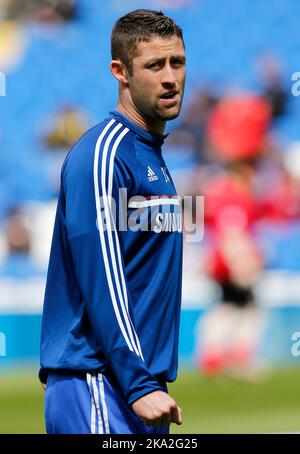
[0,369,300,434]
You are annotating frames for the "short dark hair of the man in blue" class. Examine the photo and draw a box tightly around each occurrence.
[111,9,184,73]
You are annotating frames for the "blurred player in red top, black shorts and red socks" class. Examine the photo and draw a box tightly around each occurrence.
[193,95,270,377]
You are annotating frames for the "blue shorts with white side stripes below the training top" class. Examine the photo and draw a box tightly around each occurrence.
[45,373,169,434]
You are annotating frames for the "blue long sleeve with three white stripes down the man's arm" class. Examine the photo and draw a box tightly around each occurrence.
[62,123,162,404]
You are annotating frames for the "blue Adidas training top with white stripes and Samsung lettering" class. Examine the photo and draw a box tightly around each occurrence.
[40,111,182,404]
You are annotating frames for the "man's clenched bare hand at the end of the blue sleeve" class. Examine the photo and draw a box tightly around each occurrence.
[132,391,182,427]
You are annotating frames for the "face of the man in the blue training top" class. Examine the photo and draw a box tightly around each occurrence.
[129,36,186,121]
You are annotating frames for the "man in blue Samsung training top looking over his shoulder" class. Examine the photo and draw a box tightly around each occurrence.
[40,10,185,434]
